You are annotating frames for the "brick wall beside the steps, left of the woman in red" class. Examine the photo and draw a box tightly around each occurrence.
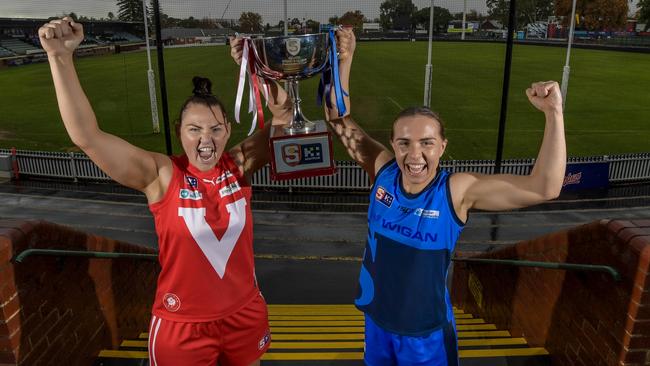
[0,220,159,366]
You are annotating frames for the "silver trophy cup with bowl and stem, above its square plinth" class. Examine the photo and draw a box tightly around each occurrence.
[252,33,330,135]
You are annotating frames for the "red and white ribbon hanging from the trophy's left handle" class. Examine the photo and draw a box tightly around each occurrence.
[235,37,269,136]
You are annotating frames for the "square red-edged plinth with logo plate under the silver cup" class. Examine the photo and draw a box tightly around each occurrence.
[269,121,336,180]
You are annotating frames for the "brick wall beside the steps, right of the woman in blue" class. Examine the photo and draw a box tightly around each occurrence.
[452,220,650,366]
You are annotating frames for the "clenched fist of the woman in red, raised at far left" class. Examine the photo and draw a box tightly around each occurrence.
[38,17,84,56]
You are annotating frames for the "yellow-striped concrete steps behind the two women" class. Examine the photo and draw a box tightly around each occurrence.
[95,304,551,366]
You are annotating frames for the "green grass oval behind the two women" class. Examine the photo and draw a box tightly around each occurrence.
[0,42,650,159]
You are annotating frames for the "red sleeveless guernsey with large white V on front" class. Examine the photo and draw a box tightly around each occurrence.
[149,152,259,322]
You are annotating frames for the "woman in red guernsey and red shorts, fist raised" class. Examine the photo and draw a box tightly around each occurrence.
[39,18,291,366]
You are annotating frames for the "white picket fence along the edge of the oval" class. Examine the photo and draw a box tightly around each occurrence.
[0,149,650,190]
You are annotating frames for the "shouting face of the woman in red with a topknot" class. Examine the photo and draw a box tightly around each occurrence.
[177,103,230,171]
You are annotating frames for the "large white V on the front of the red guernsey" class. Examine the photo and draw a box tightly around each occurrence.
[178,198,246,278]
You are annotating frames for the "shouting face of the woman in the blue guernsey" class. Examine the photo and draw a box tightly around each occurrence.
[391,115,447,193]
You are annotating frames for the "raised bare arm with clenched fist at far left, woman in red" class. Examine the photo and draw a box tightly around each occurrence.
[38,17,171,202]
